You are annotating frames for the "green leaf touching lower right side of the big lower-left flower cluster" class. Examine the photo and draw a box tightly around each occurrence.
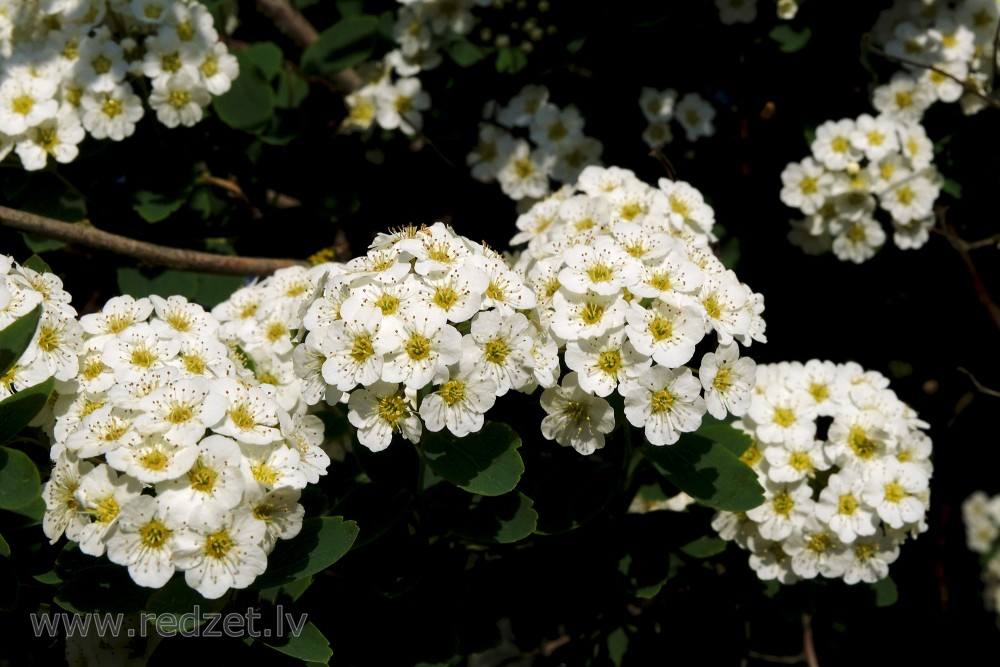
[254,516,358,589]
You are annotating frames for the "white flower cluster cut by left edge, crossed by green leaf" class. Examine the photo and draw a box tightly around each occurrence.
[0,255,83,400]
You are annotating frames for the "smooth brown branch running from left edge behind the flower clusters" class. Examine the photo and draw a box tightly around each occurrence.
[0,206,305,276]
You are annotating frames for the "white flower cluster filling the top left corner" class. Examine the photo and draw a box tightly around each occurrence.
[0,0,239,170]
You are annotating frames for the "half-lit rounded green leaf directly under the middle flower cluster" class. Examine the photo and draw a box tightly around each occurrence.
[424,422,524,496]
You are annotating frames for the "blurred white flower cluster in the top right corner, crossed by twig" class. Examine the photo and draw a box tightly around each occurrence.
[872,0,1000,121]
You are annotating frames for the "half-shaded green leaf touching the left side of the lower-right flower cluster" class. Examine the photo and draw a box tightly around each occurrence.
[642,433,764,512]
